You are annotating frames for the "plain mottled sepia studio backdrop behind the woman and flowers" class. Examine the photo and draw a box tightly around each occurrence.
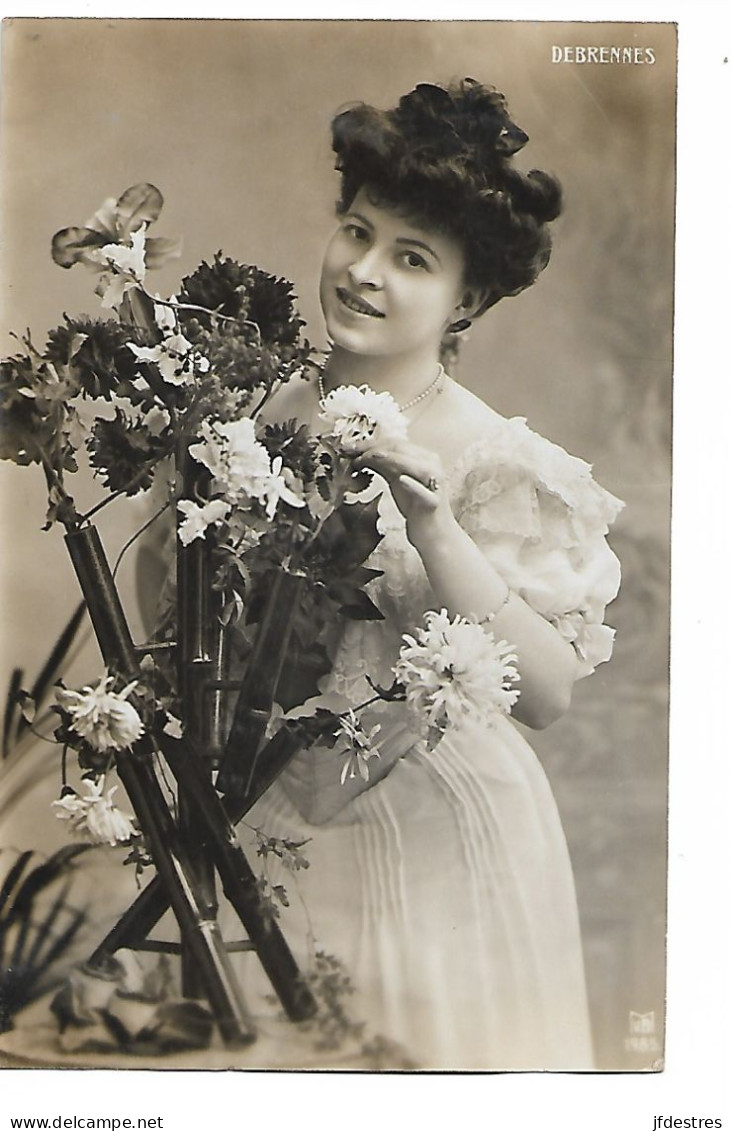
[0,19,677,1069]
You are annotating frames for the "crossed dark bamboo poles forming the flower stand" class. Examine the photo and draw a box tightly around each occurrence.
[66,526,316,1044]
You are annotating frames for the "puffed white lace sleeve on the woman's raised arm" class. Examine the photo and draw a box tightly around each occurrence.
[455,417,623,677]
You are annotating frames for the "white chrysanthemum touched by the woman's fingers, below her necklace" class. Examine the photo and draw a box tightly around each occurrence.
[318,385,407,456]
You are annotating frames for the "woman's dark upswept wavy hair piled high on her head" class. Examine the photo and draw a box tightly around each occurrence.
[333,78,561,311]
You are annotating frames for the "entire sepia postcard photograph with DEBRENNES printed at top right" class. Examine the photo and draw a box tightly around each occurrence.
[0,17,674,1076]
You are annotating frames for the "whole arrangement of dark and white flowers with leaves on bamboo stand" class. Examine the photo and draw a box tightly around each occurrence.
[0,178,518,1049]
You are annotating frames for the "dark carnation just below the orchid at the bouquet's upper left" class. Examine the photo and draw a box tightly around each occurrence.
[46,316,136,400]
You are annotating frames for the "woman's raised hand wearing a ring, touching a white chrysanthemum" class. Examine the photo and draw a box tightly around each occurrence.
[354,440,455,549]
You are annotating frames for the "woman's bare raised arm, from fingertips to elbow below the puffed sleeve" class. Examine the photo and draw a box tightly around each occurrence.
[360,444,577,729]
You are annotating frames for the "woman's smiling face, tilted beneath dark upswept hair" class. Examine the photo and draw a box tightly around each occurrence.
[320,189,465,357]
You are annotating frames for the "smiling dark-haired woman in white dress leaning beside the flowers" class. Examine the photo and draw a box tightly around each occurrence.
[236,79,620,1070]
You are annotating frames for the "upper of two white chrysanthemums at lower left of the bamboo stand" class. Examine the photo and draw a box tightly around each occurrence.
[55,675,145,750]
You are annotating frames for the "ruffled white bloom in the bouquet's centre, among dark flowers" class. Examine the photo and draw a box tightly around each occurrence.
[190,416,304,519]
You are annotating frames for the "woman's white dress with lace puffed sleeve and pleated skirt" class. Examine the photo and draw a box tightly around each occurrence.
[236,416,621,1070]
